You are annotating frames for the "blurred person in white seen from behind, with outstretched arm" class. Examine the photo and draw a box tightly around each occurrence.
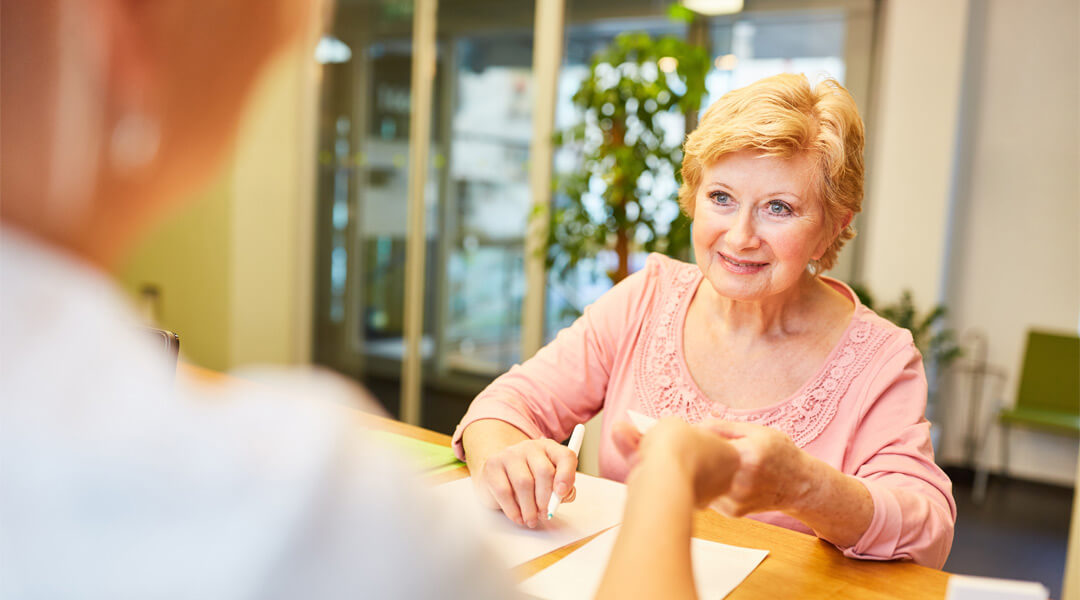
[0,0,738,599]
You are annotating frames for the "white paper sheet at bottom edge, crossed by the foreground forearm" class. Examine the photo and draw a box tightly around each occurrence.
[521,528,769,600]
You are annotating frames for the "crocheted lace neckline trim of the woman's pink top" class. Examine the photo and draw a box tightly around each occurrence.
[634,261,888,447]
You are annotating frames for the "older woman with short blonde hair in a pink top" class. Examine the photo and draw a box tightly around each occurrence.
[454,74,956,567]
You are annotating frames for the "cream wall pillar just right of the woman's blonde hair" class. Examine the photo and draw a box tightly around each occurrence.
[860,0,968,306]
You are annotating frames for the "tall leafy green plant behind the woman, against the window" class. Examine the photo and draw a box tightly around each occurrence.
[541,32,710,283]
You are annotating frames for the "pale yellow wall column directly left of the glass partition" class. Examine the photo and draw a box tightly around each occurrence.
[229,50,315,366]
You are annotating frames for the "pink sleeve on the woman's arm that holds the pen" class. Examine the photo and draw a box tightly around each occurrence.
[453,260,659,460]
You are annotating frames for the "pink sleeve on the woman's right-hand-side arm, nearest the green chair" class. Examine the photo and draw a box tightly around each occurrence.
[841,331,956,569]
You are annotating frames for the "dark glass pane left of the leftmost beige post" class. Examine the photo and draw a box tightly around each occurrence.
[314,1,421,411]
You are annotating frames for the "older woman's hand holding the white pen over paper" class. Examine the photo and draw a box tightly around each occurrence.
[472,439,578,528]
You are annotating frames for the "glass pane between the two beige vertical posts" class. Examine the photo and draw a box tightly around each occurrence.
[440,29,532,377]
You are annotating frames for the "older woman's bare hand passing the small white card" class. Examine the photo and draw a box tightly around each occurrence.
[701,421,813,517]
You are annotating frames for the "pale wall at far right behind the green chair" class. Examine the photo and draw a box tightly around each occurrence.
[946,0,1080,483]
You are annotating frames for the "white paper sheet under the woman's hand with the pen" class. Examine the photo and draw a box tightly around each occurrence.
[434,473,626,567]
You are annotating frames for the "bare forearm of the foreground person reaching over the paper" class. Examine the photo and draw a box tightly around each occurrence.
[596,461,697,599]
